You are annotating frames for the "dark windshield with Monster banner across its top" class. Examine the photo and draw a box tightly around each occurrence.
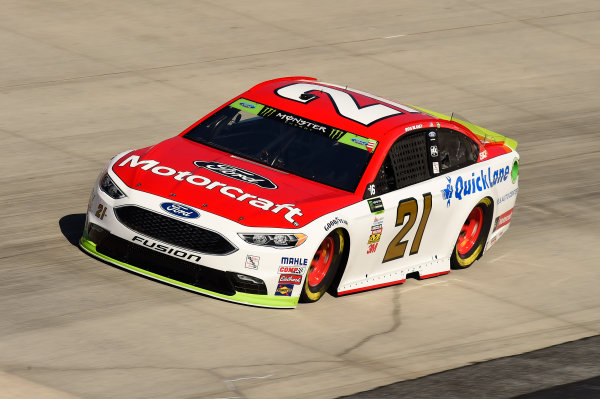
[184,99,377,191]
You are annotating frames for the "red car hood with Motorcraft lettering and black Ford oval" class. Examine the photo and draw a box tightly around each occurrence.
[112,136,360,228]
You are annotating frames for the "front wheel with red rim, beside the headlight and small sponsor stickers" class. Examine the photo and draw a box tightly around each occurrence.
[300,230,345,302]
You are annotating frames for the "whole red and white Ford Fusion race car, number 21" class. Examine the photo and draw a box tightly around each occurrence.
[80,77,519,308]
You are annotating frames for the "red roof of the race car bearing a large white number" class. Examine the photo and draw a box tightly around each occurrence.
[238,77,437,141]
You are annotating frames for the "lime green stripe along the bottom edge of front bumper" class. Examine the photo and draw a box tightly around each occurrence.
[79,237,299,308]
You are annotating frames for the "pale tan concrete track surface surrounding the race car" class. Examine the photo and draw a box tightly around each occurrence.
[0,0,600,399]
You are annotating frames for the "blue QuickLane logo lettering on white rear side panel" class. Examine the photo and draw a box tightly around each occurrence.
[441,166,510,207]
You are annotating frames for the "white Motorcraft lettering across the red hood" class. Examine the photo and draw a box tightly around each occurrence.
[118,155,302,226]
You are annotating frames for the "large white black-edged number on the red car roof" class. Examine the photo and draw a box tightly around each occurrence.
[275,83,418,126]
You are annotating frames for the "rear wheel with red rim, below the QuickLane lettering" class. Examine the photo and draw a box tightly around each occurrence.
[450,198,492,269]
